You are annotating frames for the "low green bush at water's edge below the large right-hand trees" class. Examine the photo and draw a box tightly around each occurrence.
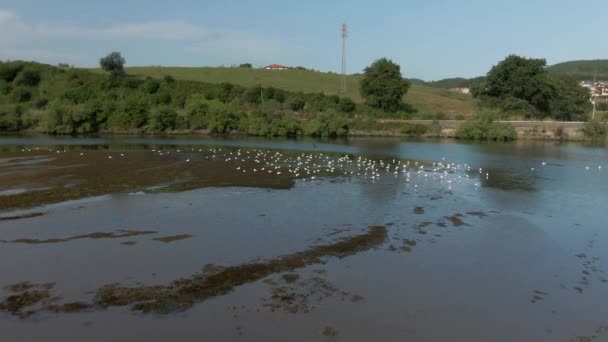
[456,113,517,141]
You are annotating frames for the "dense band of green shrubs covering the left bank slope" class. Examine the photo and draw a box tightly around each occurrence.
[0,62,366,136]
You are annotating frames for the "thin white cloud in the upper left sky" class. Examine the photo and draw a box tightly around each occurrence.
[0,9,282,64]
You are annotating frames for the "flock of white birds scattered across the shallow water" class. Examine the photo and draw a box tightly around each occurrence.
[13,147,602,194]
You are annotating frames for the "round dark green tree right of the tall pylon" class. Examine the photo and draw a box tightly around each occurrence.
[360,58,410,112]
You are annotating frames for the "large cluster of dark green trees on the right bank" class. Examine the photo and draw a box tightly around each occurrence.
[472,55,590,120]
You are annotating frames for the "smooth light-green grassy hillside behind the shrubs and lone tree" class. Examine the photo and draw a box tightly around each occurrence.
[119,67,478,118]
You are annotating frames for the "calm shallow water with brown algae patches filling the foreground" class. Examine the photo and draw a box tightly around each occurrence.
[0,137,608,341]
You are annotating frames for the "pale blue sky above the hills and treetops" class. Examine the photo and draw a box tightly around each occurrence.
[0,0,608,80]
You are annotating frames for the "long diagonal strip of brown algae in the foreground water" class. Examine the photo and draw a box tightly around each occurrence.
[0,226,387,318]
